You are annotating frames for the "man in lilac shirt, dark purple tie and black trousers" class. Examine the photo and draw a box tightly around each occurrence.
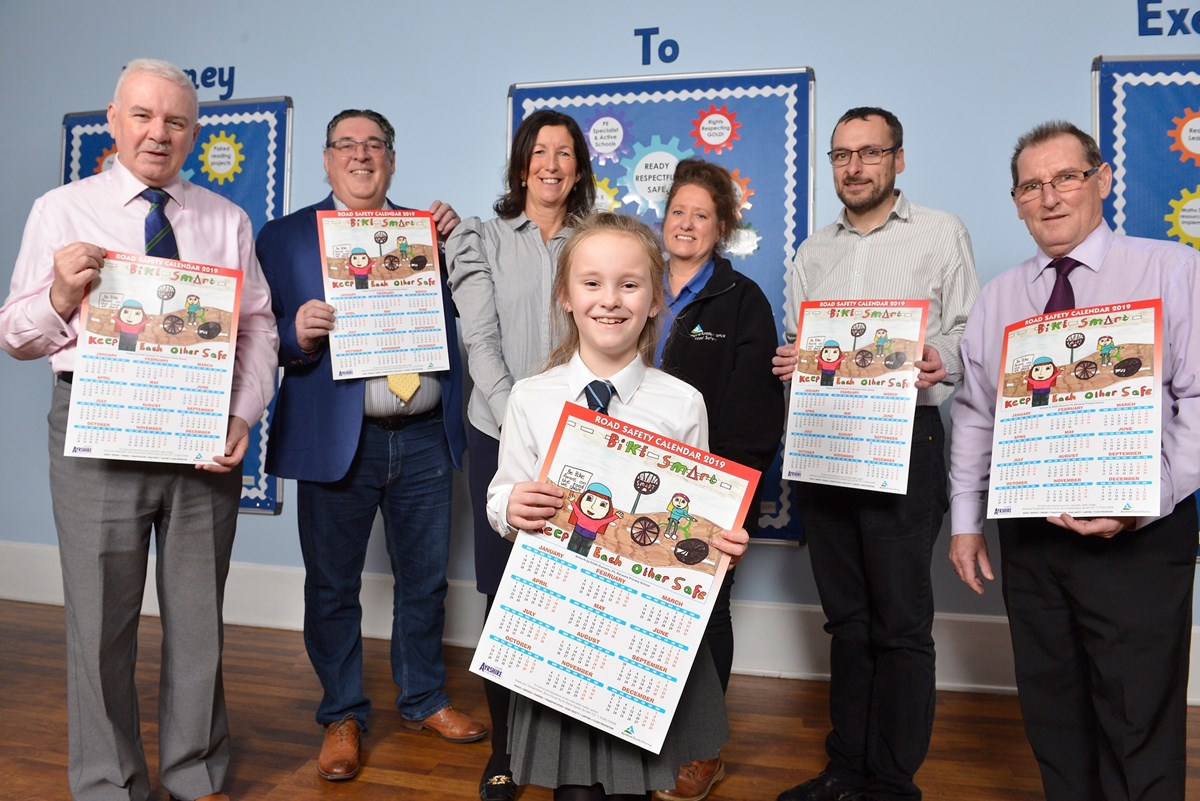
[950,122,1200,801]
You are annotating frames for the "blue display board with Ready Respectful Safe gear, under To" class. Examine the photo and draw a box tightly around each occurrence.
[509,68,814,540]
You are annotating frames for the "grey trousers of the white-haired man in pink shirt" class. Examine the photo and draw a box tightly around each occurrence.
[48,380,241,801]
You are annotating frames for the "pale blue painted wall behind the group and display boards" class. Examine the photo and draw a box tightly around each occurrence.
[0,0,1200,614]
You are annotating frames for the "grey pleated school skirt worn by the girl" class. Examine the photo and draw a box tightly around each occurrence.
[509,639,730,795]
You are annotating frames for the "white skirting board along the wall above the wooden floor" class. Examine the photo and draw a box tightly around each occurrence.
[0,541,1200,705]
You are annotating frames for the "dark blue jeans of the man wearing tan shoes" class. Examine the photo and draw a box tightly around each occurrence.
[298,415,452,729]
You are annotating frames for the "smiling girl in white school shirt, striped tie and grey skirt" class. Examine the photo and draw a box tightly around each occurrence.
[487,213,749,801]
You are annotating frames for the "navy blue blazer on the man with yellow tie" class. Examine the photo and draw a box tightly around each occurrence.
[256,194,467,482]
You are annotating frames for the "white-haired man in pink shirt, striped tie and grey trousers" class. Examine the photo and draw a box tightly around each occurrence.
[0,59,278,801]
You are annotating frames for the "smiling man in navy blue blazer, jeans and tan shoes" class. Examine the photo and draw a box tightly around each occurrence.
[257,109,487,781]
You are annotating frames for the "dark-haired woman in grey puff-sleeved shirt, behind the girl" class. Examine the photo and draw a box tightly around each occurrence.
[446,110,595,801]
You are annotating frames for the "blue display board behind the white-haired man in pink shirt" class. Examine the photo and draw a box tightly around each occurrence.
[62,97,292,514]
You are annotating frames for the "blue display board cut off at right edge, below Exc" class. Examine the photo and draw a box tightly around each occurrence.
[1092,56,1200,537]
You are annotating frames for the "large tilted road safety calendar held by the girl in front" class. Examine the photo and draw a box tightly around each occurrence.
[472,403,758,753]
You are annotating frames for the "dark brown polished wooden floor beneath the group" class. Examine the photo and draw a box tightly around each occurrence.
[0,601,1200,801]
